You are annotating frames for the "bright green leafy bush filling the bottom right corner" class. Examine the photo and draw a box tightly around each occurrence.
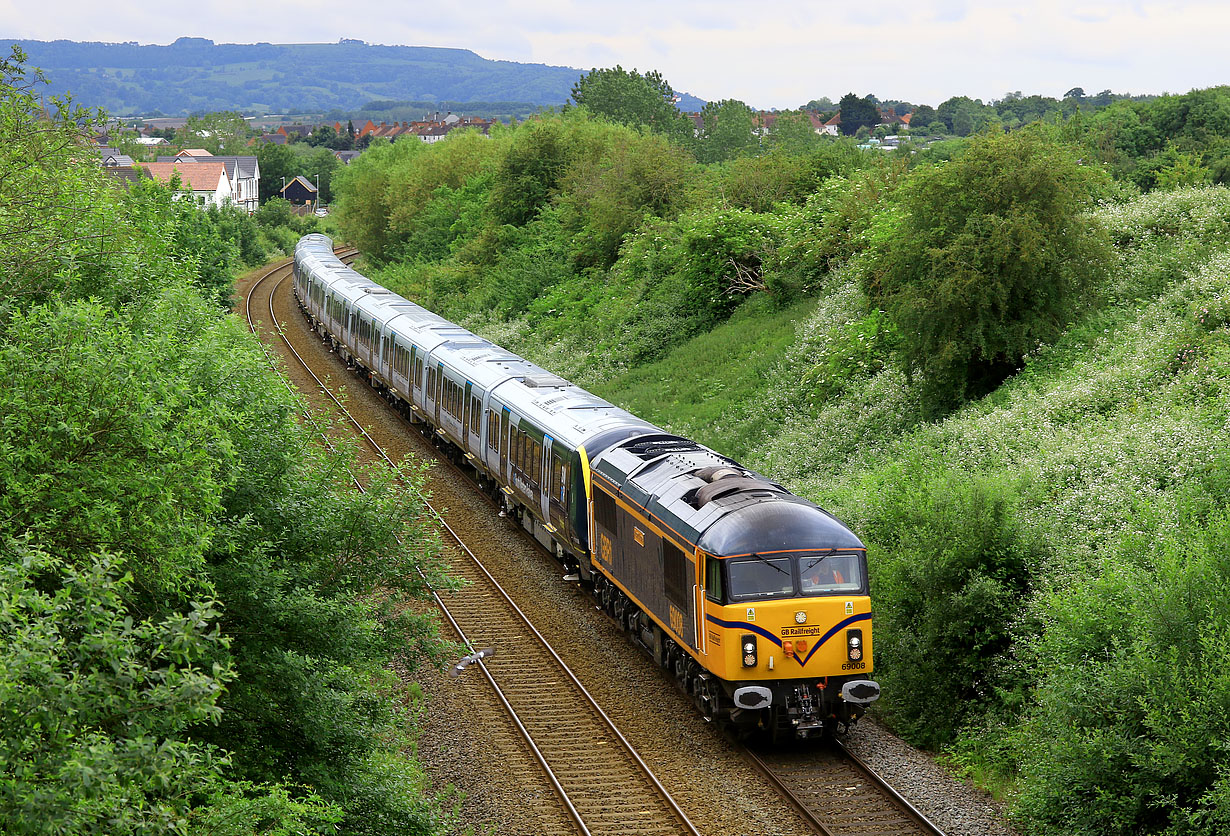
[1017,504,1230,836]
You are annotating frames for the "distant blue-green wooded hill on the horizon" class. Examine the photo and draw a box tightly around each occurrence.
[9,38,704,116]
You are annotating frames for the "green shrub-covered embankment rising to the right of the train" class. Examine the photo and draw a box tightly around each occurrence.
[335,71,1230,836]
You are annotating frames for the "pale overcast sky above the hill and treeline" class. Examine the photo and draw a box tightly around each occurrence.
[0,0,1230,108]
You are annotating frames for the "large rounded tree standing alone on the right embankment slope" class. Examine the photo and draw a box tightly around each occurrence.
[862,130,1109,413]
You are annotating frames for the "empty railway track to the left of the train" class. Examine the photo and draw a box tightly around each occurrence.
[244,251,699,835]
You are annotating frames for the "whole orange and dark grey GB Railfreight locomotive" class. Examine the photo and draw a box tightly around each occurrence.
[581,434,879,736]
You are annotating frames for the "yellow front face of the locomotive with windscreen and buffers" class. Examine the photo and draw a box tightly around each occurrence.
[705,548,879,736]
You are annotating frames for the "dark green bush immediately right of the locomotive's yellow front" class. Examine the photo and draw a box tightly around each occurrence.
[861,459,1042,749]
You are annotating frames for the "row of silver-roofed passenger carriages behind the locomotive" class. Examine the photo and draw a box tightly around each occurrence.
[294,235,662,567]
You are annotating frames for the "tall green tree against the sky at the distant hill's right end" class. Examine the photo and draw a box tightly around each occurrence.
[572,64,691,139]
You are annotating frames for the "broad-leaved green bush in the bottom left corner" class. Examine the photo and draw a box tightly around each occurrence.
[0,540,230,835]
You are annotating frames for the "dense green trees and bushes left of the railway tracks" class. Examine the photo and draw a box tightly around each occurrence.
[0,50,450,836]
